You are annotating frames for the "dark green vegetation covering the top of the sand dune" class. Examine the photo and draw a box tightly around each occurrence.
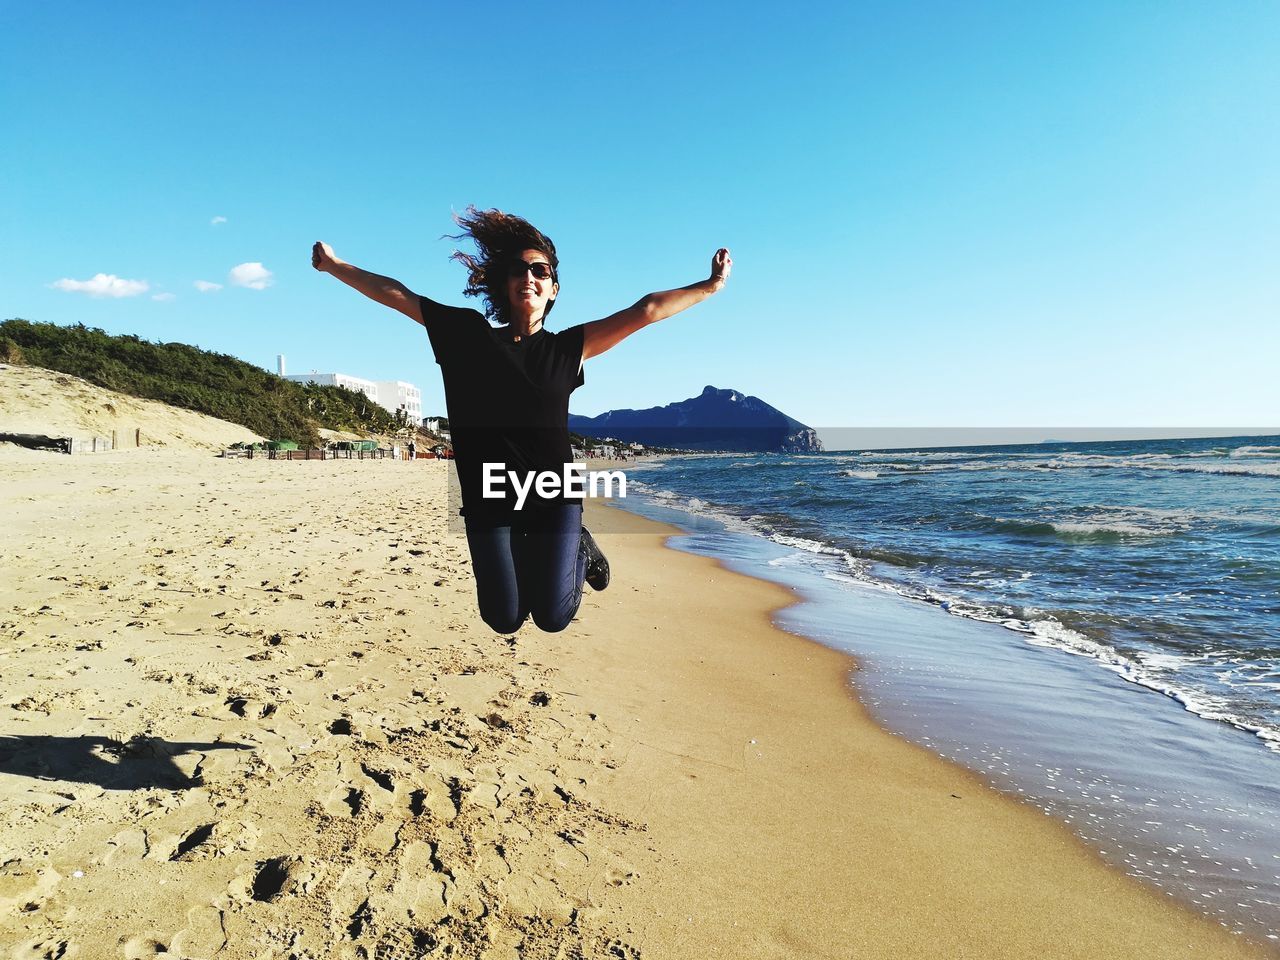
[0,319,406,447]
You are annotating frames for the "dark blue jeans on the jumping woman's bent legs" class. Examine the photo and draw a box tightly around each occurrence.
[467,503,586,634]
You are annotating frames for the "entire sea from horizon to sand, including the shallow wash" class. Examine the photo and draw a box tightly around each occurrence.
[611,436,1280,942]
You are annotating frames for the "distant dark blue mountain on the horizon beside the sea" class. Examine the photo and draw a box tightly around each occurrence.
[568,387,822,453]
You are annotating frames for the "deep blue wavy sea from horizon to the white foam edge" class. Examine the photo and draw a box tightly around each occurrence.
[631,436,1280,753]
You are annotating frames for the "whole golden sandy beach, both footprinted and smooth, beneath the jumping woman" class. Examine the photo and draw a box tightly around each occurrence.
[0,449,1268,960]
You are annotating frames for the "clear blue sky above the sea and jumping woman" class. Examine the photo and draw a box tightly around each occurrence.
[0,3,1280,428]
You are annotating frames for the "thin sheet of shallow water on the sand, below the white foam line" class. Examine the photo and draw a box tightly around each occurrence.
[611,495,1280,942]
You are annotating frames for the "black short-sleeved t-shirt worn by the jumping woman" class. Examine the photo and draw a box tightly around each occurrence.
[420,297,584,524]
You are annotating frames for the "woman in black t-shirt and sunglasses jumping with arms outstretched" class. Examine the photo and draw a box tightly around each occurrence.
[311,206,733,634]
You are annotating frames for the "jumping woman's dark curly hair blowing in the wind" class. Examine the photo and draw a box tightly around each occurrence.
[449,205,559,325]
